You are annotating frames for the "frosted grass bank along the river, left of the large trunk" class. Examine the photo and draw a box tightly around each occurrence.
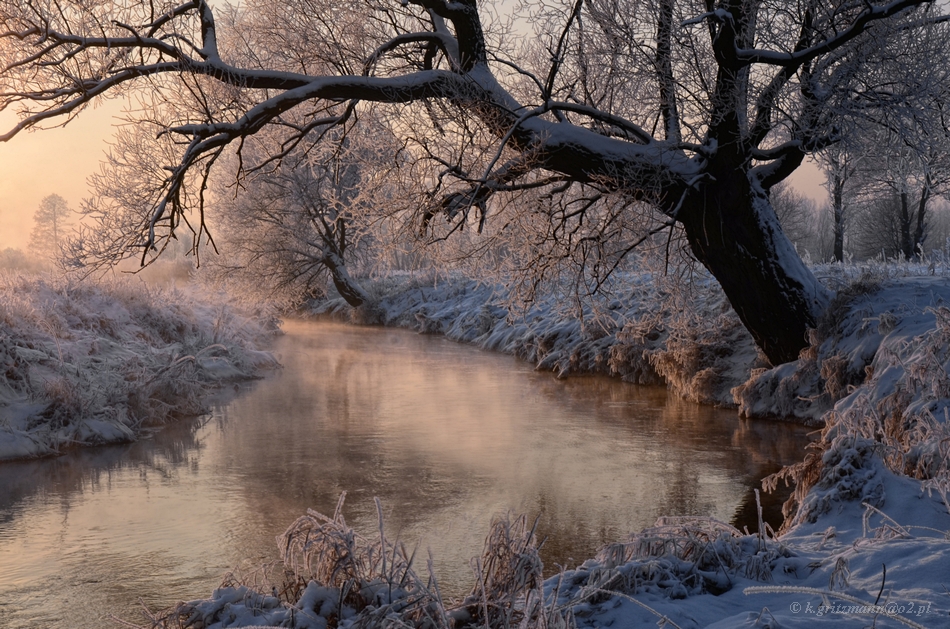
[312,272,764,406]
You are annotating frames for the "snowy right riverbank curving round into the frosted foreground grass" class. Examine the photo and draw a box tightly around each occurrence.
[156,266,950,629]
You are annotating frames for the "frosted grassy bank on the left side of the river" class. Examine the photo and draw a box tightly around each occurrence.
[0,273,276,460]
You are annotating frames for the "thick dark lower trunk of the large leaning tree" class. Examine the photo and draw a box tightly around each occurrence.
[680,164,830,365]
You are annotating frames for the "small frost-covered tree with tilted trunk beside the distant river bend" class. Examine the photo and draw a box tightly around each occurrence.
[207,131,400,307]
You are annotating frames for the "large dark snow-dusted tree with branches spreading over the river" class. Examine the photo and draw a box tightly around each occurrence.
[0,0,948,363]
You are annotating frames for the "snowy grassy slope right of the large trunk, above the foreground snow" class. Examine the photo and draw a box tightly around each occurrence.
[734,264,950,528]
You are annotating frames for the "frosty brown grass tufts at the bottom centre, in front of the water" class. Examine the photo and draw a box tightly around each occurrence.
[153,494,565,629]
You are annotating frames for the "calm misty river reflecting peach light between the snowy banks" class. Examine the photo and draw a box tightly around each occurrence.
[0,322,806,629]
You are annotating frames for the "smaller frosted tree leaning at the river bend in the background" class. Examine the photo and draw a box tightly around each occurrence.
[204,107,401,307]
